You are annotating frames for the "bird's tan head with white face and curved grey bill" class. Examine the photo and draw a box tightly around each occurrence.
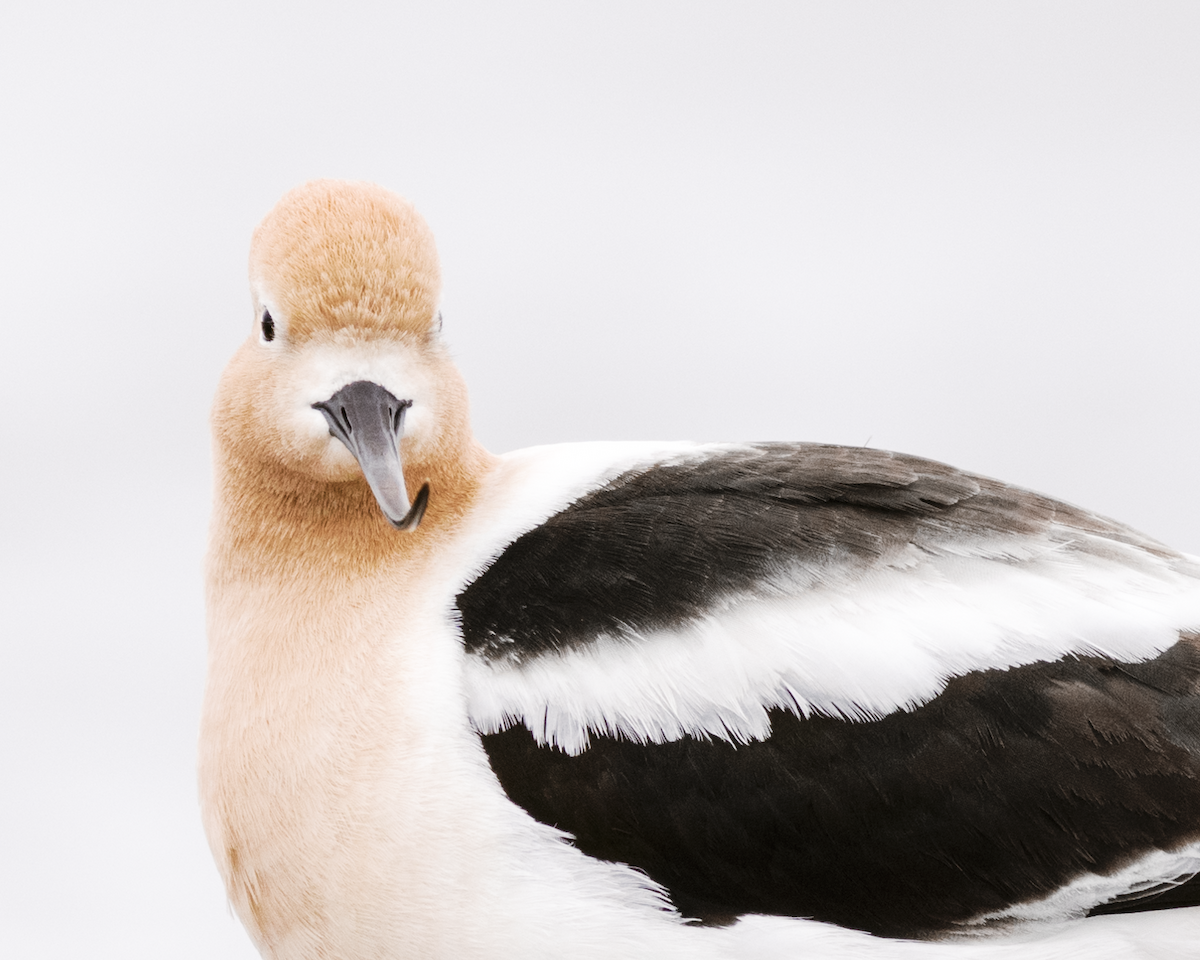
[214,180,473,529]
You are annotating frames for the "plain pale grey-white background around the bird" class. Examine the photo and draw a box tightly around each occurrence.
[0,0,1200,960]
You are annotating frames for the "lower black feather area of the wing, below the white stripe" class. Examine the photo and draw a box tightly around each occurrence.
[484,637,1200,937]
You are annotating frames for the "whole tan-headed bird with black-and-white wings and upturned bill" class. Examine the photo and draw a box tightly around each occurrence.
[199,180,1200,960]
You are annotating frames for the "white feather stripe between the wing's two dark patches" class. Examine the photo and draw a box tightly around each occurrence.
[466,541,1200,754]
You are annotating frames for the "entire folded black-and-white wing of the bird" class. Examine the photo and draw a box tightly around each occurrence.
[457,445,1200,936]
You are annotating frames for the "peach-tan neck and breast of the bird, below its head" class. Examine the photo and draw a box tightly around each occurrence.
[200,439,491,958]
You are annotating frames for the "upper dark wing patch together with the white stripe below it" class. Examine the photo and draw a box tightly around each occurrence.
[456,444,1200,752]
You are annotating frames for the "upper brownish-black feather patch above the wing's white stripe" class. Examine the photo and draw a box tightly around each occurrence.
[456,444,1182,661]
